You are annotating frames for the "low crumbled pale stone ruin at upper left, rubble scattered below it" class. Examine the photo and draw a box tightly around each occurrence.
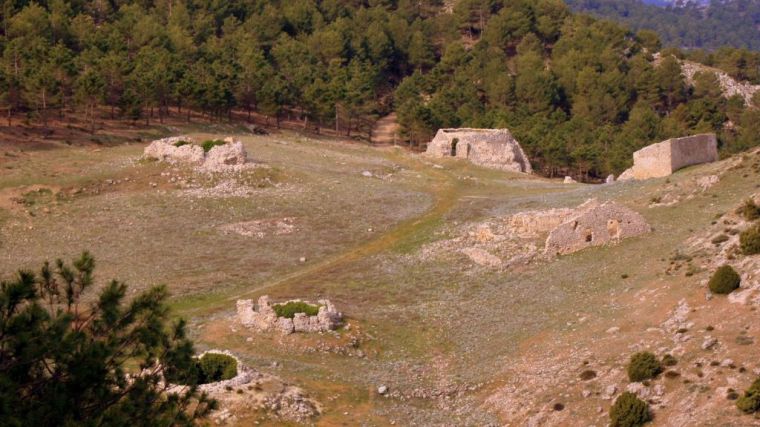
[143,136,248,172]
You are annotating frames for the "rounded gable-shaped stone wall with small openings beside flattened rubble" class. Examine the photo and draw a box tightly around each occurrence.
[544,200,652,255]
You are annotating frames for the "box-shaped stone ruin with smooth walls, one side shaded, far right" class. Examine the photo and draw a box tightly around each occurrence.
[618,133,718,181]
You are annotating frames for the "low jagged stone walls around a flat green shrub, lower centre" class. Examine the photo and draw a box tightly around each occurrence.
[237,295,343,335]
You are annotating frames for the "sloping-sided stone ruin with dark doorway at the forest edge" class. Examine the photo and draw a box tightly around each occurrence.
[426,128,533,173]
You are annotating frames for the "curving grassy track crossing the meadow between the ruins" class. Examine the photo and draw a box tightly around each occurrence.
[175,149,461,316]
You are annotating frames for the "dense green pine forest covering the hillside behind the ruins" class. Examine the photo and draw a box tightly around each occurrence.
[0,0,760,179]
